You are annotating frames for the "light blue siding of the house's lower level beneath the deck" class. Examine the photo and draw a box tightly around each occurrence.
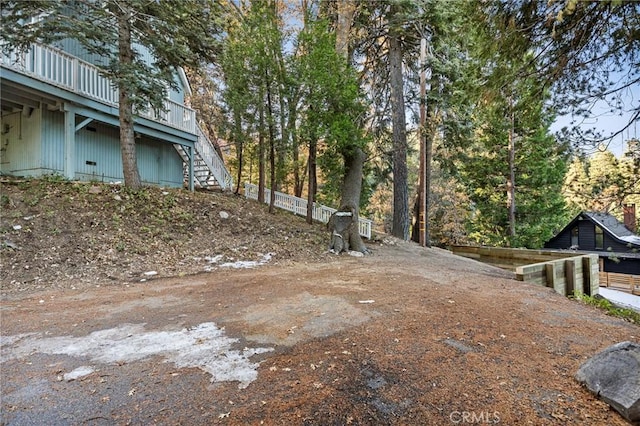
[1,109,184,187]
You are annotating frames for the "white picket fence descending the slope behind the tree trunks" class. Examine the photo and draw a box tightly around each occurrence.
[244,182,373,238]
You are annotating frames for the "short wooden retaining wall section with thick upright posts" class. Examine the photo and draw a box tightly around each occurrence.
[516,254,600,296]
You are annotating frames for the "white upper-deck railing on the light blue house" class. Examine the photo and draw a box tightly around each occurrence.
[1,44,196,133]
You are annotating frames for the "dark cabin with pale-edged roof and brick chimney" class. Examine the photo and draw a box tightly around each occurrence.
[544,204,640,275]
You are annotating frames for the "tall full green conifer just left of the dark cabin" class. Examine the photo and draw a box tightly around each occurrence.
[454,0,567,248]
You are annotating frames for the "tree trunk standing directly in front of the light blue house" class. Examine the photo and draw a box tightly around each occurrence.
[118,2,142,189]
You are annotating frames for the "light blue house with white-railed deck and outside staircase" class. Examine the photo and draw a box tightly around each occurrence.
[0,40,233,189]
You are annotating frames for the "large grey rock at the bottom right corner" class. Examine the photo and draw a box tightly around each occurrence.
[576,342,640,423]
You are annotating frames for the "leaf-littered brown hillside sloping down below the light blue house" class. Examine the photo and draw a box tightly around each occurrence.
[0,178,332,295]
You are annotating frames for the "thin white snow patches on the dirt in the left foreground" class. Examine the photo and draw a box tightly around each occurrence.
[0,322,273,389]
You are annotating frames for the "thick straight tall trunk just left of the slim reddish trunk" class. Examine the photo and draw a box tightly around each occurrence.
[388,27,409,240]
